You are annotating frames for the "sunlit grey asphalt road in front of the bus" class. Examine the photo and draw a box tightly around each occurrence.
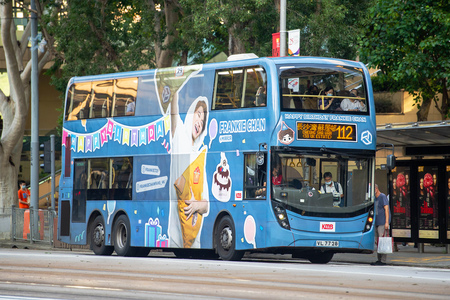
[0,249,450,299]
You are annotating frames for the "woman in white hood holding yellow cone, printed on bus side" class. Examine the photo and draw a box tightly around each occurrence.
[168,91,209,248]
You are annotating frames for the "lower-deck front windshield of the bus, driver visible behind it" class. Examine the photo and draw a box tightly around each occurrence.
[271,149,372,216]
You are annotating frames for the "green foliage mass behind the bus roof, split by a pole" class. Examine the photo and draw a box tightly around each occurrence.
[41,0,376,125]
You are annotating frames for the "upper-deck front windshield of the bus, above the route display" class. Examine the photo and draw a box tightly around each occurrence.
[279,65,368,114]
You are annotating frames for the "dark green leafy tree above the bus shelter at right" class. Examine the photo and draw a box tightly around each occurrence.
[360,0,450,121]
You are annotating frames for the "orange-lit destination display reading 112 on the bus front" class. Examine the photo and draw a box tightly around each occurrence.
[297,122,356,142]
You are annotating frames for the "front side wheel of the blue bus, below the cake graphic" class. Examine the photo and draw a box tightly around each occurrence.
[214,215,244,260]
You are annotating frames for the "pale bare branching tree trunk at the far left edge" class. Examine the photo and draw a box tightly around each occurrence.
[0,1,51,210]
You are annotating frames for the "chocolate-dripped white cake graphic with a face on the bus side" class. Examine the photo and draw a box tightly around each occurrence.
[211,152,231,202]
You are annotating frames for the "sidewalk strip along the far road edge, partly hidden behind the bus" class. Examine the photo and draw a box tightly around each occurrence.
[0,240,450,269]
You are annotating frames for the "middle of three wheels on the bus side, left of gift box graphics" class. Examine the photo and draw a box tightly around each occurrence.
[113,215,136,256]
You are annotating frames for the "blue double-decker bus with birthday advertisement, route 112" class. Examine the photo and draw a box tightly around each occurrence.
[58,57,376,263]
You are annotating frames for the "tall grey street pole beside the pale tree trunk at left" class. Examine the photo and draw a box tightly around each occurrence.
[30,0,39,243]
